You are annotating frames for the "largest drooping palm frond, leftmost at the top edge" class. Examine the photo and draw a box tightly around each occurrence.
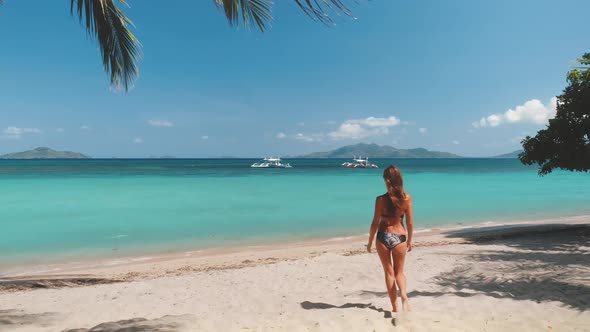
[70,0,141,91]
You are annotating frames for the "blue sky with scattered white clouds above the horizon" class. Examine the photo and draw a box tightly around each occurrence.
[0,0,590,157]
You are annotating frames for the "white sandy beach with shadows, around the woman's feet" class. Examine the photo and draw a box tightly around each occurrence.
[0,218,590,332]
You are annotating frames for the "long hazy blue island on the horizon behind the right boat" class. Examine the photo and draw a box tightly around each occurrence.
[297,143,462,158]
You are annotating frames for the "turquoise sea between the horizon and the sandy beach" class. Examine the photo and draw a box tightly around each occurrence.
[0,159,590,264]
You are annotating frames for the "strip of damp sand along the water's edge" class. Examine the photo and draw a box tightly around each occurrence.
[0,215,590,282]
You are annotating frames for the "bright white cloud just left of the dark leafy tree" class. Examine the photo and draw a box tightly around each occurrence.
[472,97,557,128]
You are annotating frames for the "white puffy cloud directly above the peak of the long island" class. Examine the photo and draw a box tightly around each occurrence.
[328,116,400,140]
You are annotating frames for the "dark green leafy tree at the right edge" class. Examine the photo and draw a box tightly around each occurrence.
[519,53,590,175]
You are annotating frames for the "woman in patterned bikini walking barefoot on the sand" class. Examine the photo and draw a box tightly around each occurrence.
[367,165,413,312]
